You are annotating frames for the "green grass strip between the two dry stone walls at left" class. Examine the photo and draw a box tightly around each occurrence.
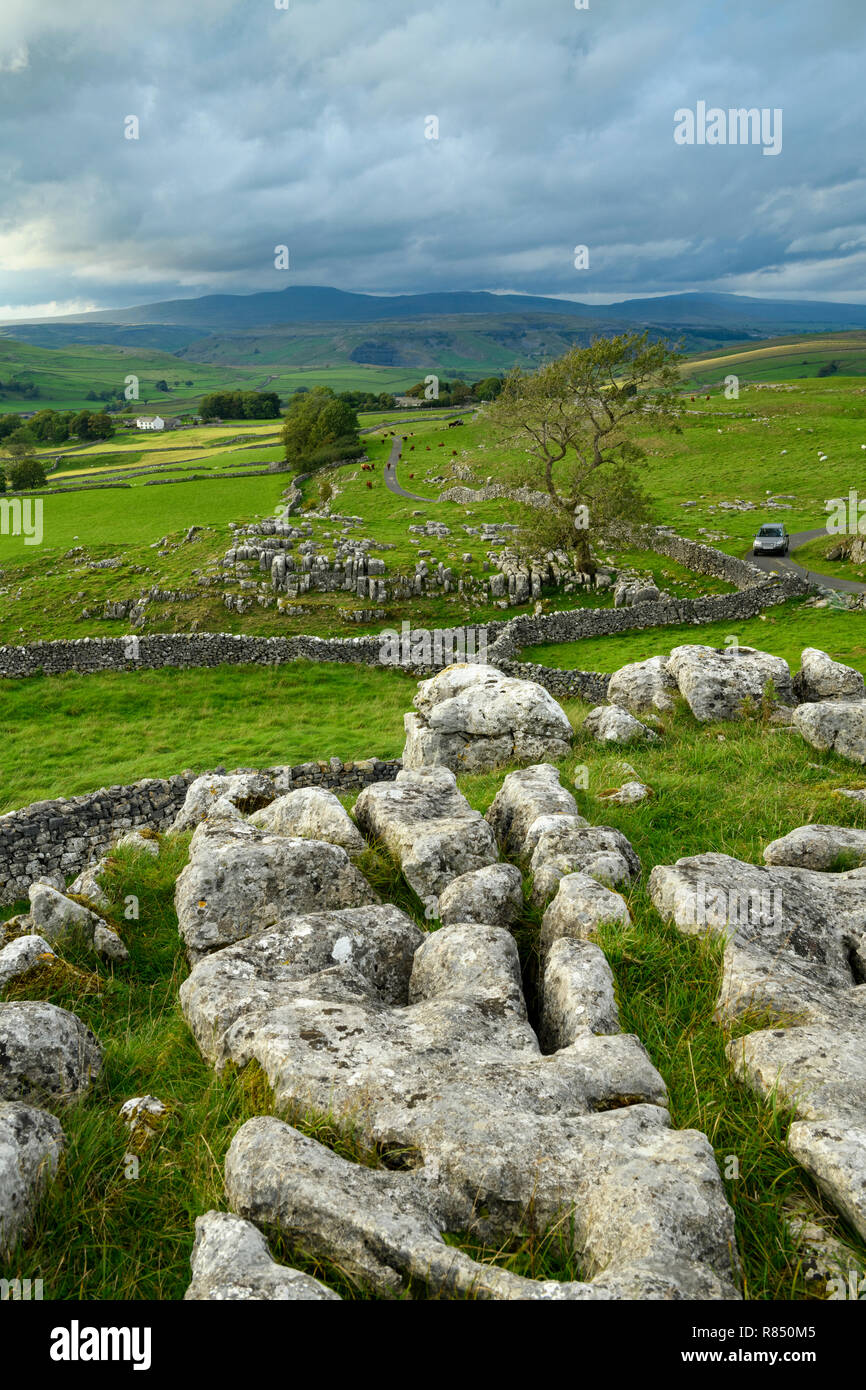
[0,662,416,813]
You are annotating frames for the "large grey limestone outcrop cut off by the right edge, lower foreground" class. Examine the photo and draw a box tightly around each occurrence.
[649,853,866,1236]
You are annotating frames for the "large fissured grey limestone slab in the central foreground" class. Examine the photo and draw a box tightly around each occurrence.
[202,908,735,1298]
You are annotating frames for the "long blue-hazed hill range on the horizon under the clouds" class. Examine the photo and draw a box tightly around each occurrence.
[0,285,866,379]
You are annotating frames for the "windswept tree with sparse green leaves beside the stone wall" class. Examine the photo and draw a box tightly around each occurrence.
[489,334,681,570]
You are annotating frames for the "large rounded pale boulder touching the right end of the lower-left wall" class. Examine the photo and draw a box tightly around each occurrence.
[403,664,571,771]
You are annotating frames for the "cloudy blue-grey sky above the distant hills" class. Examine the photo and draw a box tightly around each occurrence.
[0,0,866,318]
